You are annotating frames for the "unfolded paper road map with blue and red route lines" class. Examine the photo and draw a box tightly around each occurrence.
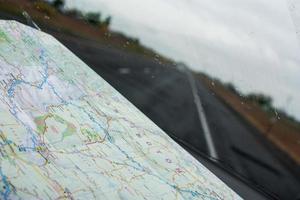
[0,20,240,199]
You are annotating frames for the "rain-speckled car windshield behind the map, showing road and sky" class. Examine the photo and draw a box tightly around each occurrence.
[0,0,300,199]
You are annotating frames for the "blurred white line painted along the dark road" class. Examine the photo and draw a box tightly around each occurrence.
[179,66,219,159]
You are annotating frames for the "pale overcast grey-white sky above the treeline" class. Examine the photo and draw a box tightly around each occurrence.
[66,0,300,120]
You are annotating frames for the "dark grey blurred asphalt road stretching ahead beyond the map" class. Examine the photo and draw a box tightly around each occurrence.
[0,13,300,199]
